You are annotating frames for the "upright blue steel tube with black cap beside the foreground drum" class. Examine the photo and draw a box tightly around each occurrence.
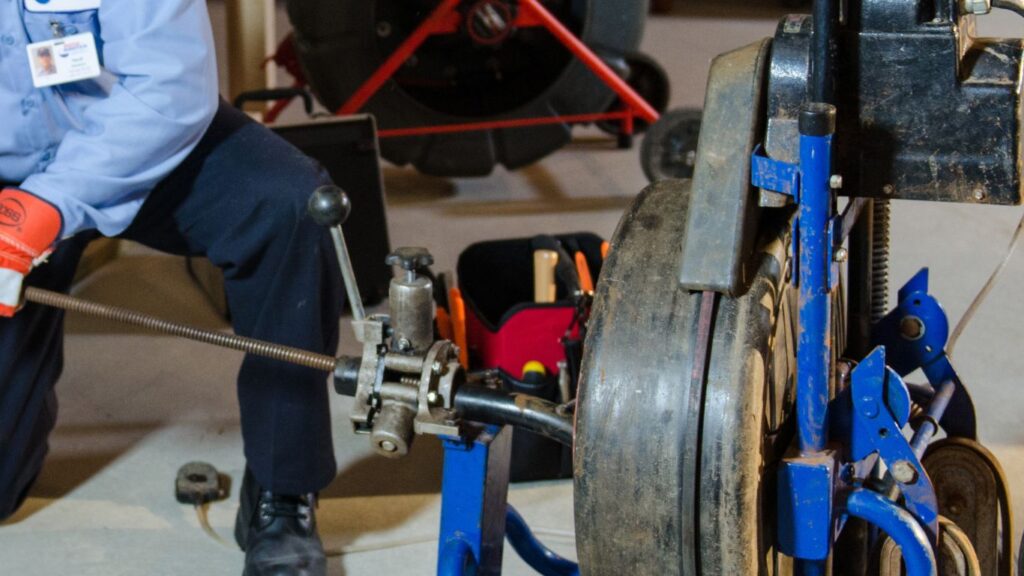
[795,104,836,576]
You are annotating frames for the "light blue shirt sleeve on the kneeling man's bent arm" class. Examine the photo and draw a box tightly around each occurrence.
[22,0,218,238]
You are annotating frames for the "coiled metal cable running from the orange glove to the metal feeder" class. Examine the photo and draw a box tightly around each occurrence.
[25,287,338,372]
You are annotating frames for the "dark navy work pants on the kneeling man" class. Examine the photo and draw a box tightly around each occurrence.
[0,102,343,519]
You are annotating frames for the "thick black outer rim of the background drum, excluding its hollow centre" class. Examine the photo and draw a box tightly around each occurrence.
[288,0,647,176]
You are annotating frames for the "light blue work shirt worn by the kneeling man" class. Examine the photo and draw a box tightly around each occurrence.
[0,0,218,238]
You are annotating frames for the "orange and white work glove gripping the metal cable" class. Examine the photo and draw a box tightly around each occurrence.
[0,188,63,317]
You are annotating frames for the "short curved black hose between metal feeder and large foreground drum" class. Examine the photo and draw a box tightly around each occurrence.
[455,384,573,447]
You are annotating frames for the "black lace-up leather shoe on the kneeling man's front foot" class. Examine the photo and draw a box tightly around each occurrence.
[234,469,327,576]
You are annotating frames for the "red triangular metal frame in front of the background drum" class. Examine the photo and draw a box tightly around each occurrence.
[264,0,658,138]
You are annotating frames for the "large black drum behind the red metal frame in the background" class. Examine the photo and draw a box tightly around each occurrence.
[288,0,647,176]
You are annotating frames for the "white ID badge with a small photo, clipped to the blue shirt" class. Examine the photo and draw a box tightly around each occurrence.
[29,33,102,88]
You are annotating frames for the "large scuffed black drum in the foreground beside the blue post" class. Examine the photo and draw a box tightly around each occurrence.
[574,180,796,576]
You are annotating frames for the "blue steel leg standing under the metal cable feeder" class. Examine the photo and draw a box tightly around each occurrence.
[437,426,512,576]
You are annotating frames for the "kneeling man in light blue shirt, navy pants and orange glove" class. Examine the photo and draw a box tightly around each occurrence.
[0,0,342,576]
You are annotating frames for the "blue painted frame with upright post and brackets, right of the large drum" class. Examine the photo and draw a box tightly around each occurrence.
[751,104,958,576]
